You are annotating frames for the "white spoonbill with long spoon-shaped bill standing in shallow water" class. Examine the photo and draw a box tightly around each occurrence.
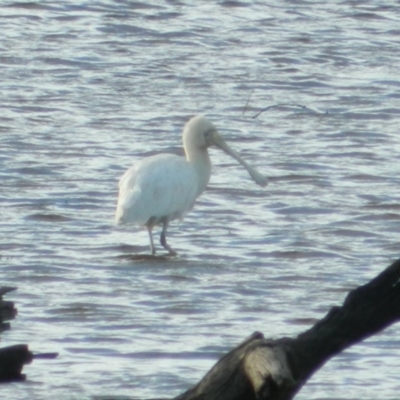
[115,115,268,255]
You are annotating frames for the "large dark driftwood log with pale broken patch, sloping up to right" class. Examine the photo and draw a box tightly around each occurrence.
[175,260,400,400]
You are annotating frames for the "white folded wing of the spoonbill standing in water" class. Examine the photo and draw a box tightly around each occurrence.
[116,154,198,225]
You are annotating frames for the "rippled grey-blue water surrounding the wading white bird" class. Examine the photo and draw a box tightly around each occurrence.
[0,0,400,400]
